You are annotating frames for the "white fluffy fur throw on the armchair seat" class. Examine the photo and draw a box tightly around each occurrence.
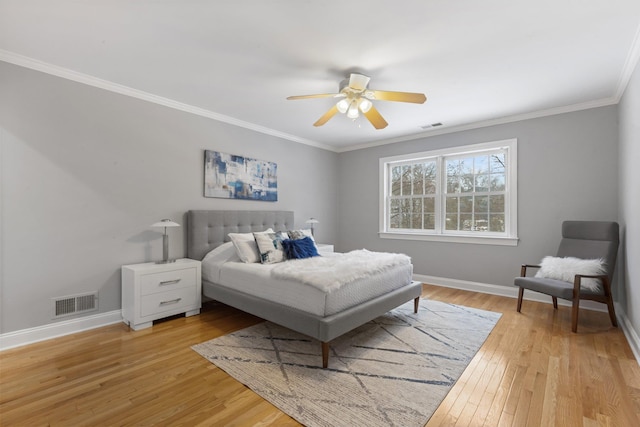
[535,256,606,292]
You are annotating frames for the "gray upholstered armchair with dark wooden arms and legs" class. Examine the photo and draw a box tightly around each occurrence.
[514,221,619,332]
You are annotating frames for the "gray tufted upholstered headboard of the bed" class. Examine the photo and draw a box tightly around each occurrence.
[187,211,294,260]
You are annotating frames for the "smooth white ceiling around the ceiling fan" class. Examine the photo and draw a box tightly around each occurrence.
[0,0,640,151]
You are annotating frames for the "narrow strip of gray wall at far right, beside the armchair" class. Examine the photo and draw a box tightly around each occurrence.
[618,60,640,331]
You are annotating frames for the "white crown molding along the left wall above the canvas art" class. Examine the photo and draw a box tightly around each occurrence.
[0,49,335,151]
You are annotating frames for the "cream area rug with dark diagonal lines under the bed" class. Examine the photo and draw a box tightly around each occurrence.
[192,300,501,427]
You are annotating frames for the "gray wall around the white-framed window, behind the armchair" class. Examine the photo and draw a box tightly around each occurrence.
[336,107,618,286]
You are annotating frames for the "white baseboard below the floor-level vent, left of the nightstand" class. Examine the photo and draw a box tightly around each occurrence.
[0,310,122,351]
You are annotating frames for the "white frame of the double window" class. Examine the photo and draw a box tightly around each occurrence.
[378,138,518,246]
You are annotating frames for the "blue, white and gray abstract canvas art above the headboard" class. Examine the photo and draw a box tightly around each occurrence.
[204,150,278,202]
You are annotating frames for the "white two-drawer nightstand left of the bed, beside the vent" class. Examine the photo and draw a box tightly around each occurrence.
[122,258,202,330]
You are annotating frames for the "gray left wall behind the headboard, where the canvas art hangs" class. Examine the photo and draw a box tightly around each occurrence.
[0,62,337,333]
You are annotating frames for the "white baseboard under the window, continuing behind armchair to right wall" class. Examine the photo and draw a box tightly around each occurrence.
[413,274,640,364]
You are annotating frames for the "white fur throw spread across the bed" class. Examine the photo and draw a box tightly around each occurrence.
[271,249,411,292]
